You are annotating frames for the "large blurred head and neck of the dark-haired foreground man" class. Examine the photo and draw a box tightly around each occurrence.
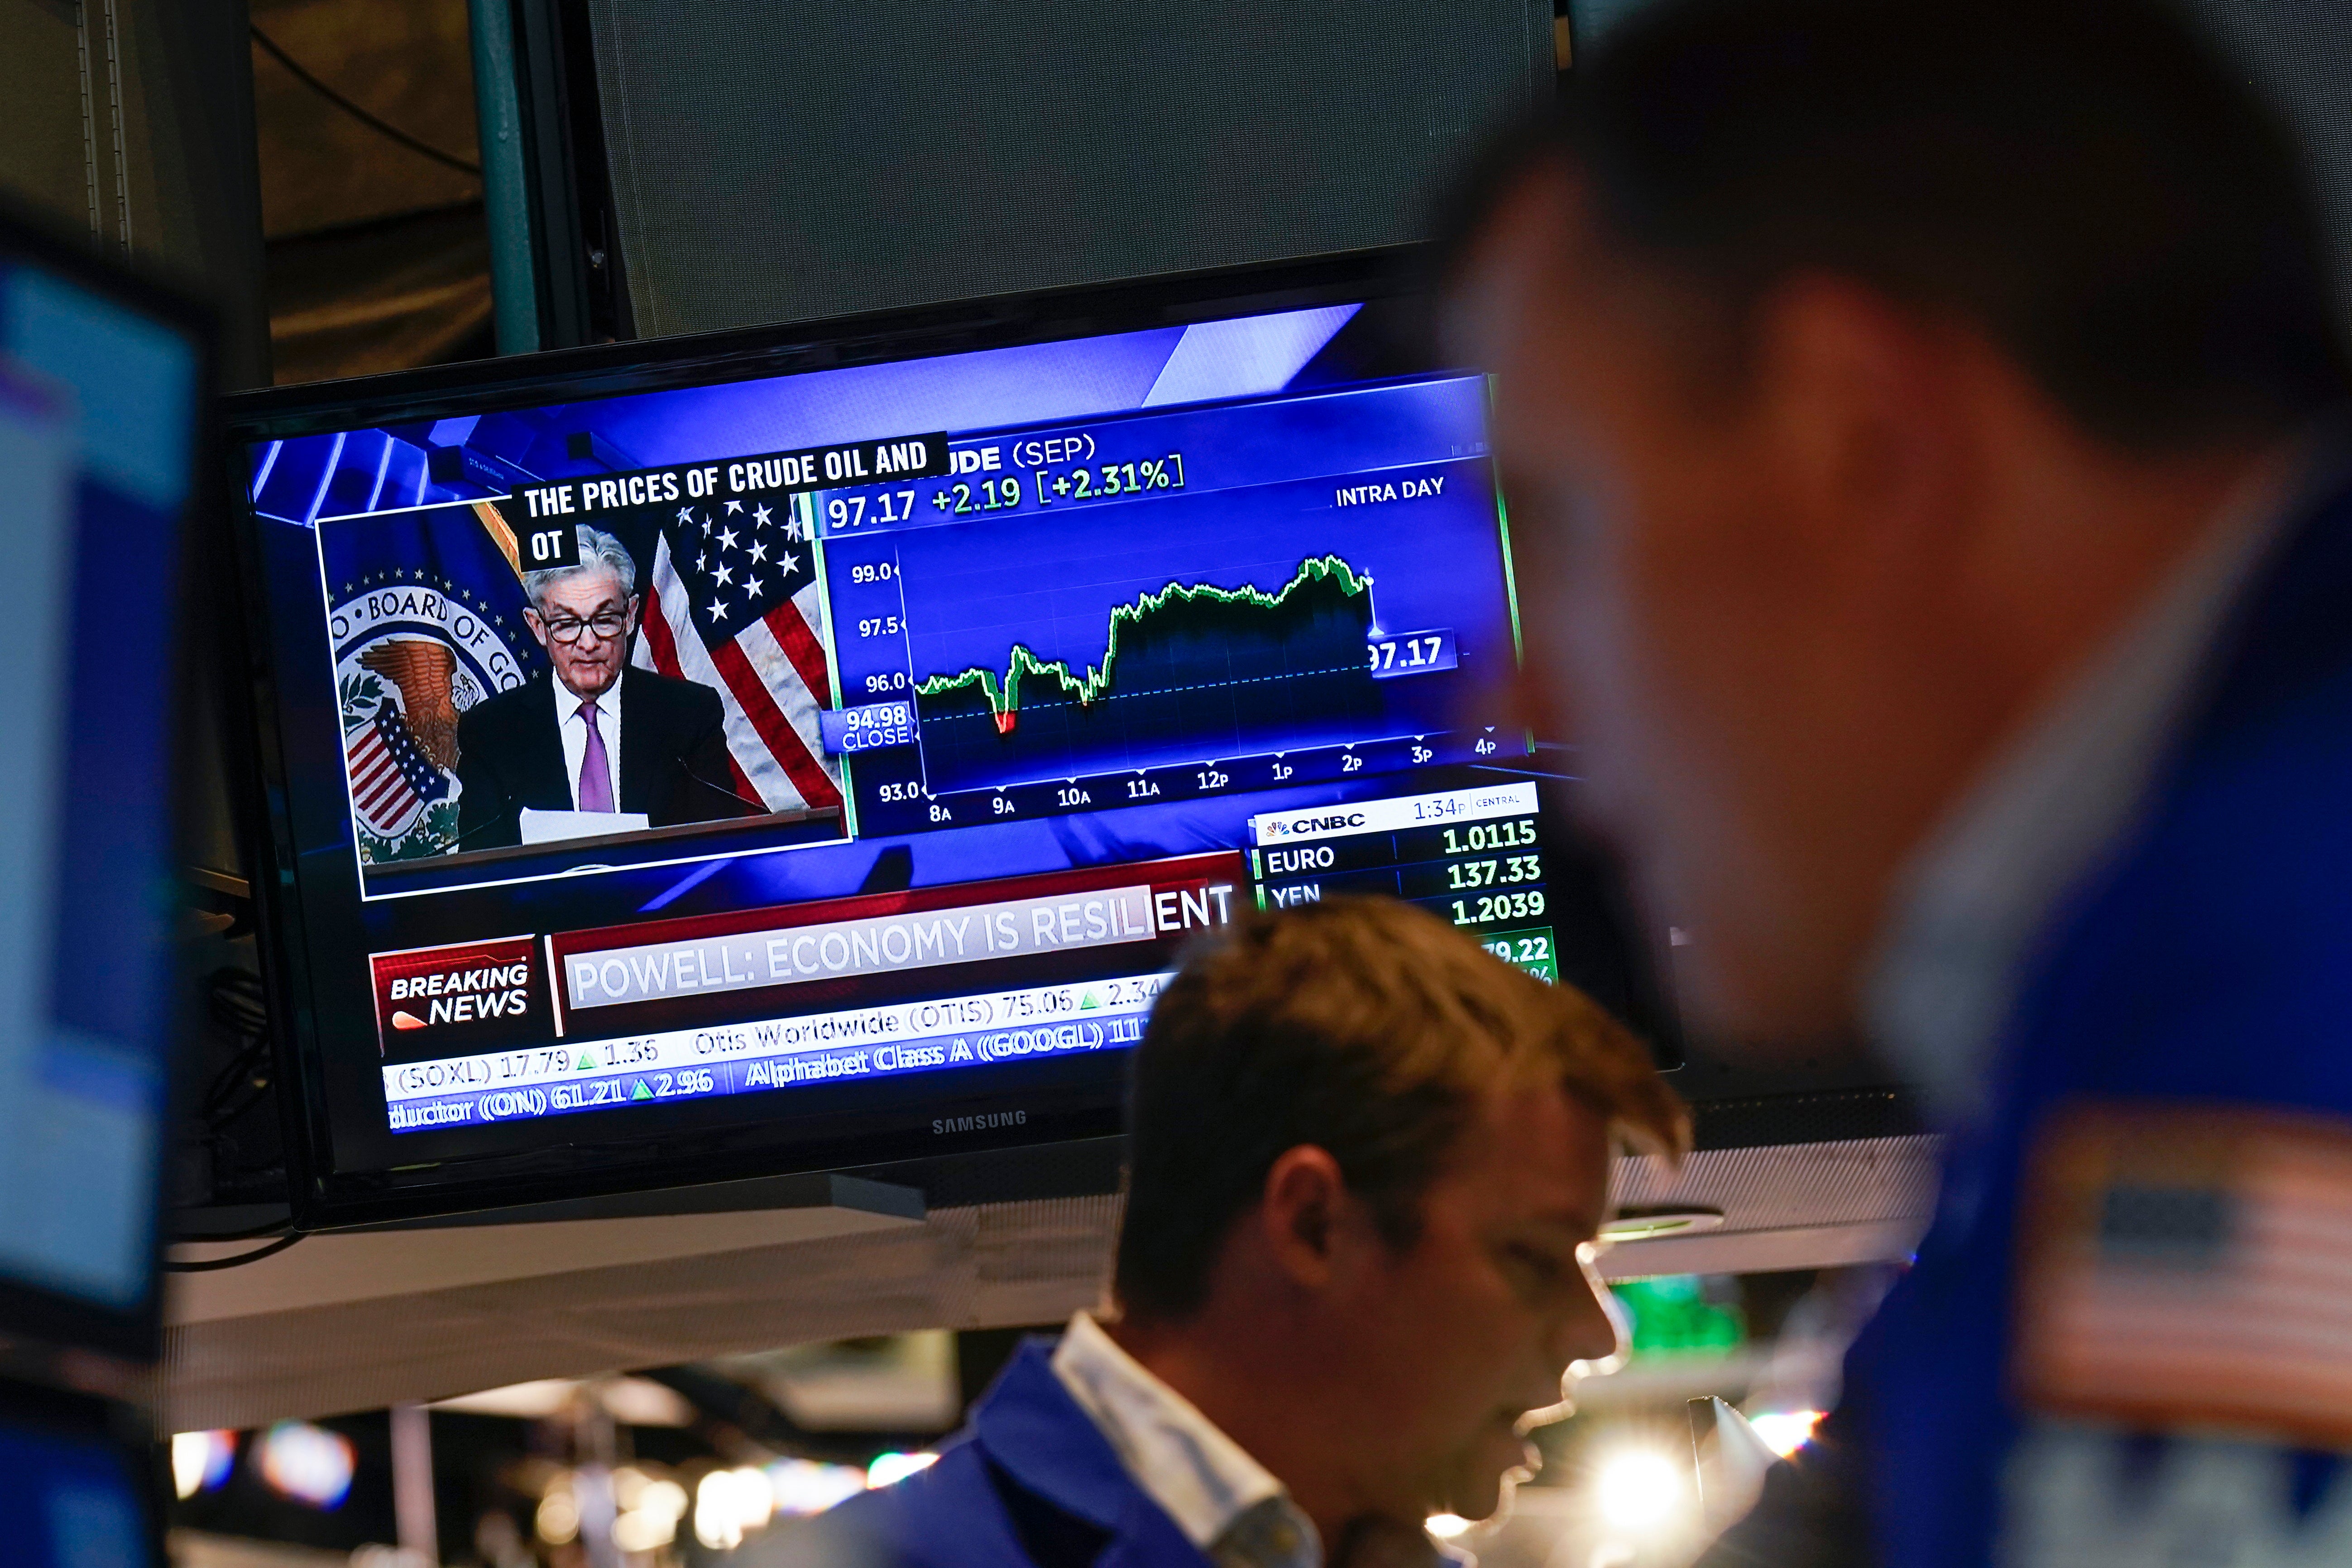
[1449,0,2347,1039]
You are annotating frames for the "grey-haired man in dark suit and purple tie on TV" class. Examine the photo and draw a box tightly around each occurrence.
[456,524,760,849]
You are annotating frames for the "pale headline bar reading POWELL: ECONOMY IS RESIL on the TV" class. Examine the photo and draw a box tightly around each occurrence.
[562,884,1166,1013]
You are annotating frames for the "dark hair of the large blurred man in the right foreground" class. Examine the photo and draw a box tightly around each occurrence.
[1449,0,2352,451]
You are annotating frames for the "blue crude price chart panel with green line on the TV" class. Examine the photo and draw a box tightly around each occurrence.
[811,383,1517,832]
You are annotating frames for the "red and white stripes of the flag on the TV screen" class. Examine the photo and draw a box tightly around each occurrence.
[632,529,842,811]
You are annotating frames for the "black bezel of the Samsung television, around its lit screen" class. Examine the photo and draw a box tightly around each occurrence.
[224,247,1656,1229]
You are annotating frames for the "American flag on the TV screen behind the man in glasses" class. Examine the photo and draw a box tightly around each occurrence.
[632,499,842,811]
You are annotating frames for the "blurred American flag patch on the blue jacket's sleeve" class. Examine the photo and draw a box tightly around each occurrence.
[2018,1105,2352,1448]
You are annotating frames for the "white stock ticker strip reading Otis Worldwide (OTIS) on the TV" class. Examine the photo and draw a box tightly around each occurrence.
[383,971,1174,1103]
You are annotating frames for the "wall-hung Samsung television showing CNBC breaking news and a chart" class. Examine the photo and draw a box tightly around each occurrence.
[230,256,1672,1227]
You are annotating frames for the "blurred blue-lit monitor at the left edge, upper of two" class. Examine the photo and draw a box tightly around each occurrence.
[0,211,209,1354]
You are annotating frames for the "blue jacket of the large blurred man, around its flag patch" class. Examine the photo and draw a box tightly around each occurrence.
[1835,489,2352,1568]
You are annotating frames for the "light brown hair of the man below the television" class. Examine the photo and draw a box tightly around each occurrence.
[1112,898,1689,1319]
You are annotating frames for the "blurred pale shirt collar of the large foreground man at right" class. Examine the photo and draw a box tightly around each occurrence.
[1863,446,2305,1122]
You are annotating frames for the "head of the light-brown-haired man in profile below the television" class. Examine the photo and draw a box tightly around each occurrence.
[1115,898,1686,1523]
